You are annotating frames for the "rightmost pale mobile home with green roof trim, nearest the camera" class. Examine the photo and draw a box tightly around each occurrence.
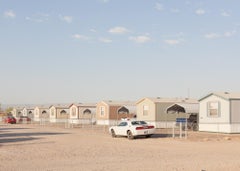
[199,92,240,133]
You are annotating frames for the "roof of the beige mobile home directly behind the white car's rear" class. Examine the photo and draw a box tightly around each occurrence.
[137,97,198,104]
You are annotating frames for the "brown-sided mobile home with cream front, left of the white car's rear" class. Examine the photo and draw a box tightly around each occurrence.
[96,100,136,125]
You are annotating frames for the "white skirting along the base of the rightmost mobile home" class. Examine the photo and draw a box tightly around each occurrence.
[199,123,240,133]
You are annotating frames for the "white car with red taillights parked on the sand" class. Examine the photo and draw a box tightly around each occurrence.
[109,120,155,139]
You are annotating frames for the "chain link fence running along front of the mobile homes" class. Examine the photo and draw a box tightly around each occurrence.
[0,118,214,138]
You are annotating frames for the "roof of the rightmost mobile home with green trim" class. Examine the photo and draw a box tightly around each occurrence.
[199,92,240,101]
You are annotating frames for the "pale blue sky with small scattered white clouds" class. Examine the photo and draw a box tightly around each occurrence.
[0,0,240,104]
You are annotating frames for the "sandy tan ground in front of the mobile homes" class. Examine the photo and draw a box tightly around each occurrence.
[0,124,240,171]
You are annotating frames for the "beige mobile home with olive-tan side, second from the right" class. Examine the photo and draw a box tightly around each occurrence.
[136,97,198,128]
